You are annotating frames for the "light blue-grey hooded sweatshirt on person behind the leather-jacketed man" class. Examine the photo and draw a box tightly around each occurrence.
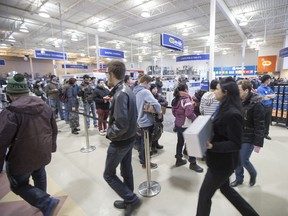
[133,85,162,128]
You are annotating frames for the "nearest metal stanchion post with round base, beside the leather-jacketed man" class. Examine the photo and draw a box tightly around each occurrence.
[138,130,161,197]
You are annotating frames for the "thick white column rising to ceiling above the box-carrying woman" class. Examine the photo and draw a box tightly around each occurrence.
[208,0,216,82]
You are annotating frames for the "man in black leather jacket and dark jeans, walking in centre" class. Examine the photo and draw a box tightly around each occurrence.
[104,60,141,215]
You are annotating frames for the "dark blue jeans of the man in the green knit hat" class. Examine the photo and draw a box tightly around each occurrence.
[6,163,51,212]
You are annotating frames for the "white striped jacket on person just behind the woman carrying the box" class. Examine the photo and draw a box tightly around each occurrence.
[199,92,219,115]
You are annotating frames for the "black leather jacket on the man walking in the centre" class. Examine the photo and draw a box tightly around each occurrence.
[106,81,137,145]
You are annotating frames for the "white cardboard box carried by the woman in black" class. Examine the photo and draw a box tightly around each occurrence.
[183,116,212,158]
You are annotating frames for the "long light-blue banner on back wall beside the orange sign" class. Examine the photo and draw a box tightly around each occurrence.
[214,65,257,76]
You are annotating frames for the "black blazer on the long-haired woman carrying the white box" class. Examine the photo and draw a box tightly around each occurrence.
[206,105,243,173]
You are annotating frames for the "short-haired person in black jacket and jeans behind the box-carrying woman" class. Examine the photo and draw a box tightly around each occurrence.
[230,80,265,187]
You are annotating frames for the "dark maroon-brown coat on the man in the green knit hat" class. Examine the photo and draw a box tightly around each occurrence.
[0,96,58,175]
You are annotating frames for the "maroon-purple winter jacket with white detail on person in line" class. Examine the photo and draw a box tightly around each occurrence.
[172,91,196,127]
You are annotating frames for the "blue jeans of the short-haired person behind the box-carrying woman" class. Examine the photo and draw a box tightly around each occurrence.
[235,143,257,182]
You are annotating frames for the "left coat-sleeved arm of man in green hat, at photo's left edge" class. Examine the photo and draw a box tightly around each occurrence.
[0,109,17,172]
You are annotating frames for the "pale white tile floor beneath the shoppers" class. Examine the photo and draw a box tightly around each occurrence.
[47,110,288,216]
